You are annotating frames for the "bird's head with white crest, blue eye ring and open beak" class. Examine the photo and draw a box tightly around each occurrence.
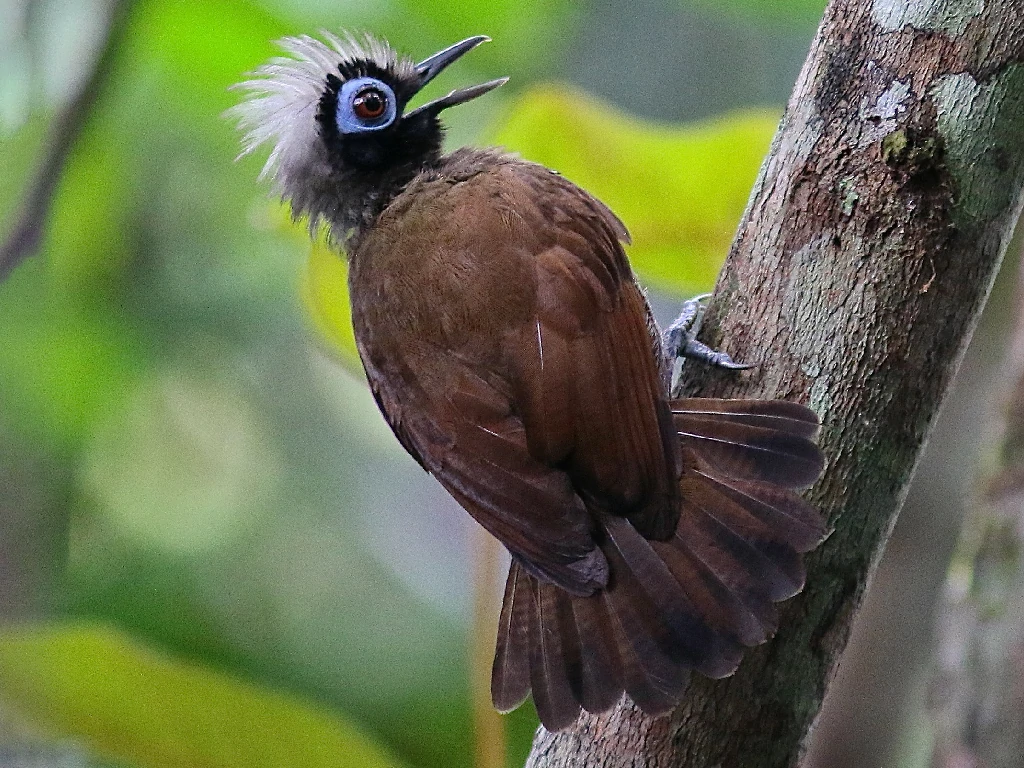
[228,33,507,236]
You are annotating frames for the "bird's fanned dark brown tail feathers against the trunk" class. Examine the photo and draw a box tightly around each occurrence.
[492,398,827,730]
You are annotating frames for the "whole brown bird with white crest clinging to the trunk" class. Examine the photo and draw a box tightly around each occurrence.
[230,32,828,731]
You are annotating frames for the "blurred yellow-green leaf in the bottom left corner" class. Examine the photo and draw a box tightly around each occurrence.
[0,625,399,768]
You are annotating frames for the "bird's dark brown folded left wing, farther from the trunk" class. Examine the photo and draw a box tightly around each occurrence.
[356,352,607,595]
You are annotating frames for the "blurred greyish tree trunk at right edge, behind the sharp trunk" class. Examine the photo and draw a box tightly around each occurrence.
[932,241,1024,768]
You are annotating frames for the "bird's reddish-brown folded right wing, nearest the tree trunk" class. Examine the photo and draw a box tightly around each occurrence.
[508,165,680,538]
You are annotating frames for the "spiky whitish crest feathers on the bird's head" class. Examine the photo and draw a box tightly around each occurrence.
[225,32,415,198]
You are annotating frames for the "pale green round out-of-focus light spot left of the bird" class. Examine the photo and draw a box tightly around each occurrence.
[79,370,284,555]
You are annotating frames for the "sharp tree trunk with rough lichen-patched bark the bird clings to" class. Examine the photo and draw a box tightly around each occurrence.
[527,0,1024,768]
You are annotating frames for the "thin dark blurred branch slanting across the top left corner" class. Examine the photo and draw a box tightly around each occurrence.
[0,0,133,282]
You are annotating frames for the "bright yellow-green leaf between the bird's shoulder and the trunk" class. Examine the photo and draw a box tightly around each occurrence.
[494,85,778,294]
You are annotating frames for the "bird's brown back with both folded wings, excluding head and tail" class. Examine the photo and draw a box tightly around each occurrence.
[351,157,679,594]
